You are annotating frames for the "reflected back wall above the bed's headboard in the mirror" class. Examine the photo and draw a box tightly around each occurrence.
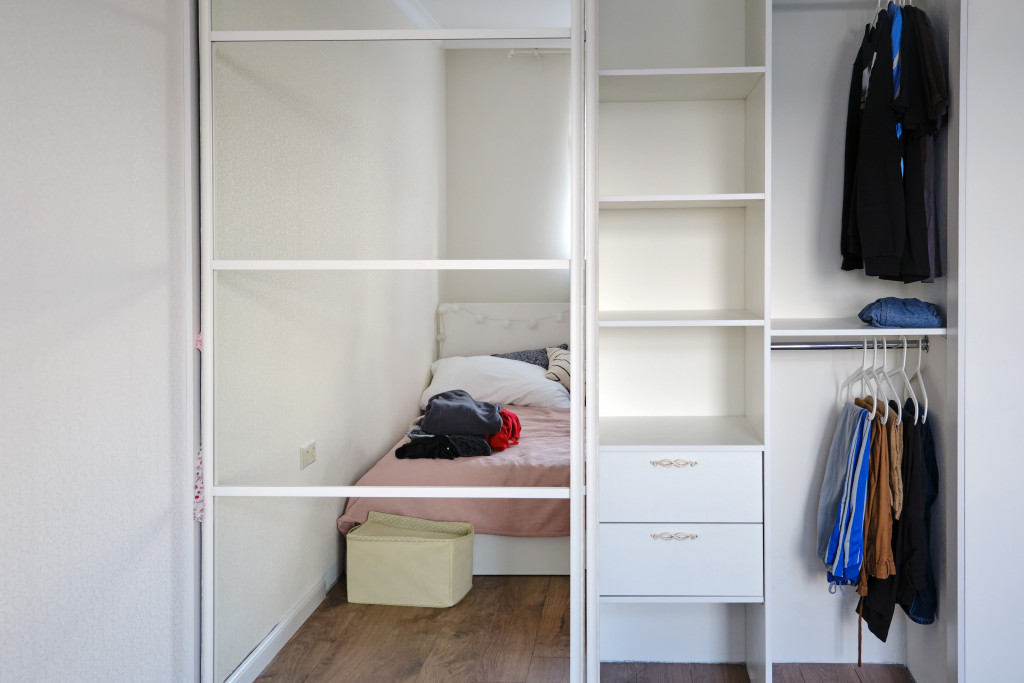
[441,49,571,302]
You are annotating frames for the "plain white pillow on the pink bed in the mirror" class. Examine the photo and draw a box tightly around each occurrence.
[420,355,569,410]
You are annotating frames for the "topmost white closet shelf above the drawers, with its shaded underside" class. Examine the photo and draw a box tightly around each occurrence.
[598,67,765,102]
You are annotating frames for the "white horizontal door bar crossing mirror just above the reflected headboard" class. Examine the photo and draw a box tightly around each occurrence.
[213,259,569,270]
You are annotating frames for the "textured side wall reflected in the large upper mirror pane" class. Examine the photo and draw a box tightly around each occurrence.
[214,42,444,258]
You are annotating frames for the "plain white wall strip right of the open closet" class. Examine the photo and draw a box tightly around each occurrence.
[963,0,1024,681]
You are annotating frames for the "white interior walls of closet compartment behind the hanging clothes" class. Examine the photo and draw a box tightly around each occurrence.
[769,0,961,681]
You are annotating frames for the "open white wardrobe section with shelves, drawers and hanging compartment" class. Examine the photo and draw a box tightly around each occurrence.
[587,0,963,681]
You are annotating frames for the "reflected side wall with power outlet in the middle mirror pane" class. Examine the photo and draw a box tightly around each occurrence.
[214,271,437,486]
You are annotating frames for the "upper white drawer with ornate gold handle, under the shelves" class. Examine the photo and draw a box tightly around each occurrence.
[598,451,764,522]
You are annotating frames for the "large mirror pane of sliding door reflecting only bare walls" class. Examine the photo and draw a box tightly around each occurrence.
[214,41,571,259]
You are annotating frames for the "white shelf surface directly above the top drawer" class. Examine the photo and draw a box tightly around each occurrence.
[598,415,764,451]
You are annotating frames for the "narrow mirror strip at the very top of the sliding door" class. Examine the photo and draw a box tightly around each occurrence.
[213,0,570,31]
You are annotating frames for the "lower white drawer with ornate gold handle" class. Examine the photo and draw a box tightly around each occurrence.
[599,523,764,597]
